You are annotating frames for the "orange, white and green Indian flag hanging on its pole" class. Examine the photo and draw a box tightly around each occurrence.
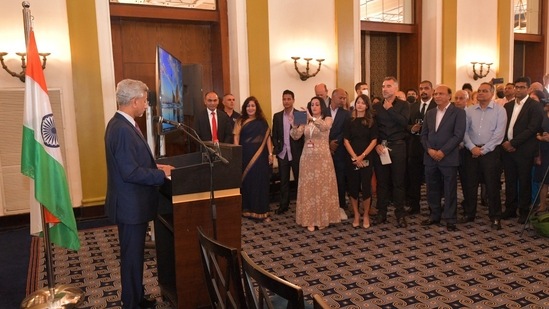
[21,29,80,250]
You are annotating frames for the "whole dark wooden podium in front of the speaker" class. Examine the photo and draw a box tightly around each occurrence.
[154,144,242,308]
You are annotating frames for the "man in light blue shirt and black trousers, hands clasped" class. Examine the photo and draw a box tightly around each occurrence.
[462,83,507,230]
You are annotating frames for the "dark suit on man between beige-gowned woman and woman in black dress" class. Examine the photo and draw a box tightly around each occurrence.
[326,107,351,208]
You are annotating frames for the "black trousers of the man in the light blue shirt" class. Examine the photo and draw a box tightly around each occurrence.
[462,146,501,220]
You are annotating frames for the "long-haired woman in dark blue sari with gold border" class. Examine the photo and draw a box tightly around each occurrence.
[234,96,273,222]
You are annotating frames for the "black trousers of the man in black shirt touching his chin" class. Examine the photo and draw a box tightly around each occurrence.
[374,140,406,218]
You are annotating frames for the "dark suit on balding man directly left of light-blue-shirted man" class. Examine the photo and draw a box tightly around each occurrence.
[421,104,466,224]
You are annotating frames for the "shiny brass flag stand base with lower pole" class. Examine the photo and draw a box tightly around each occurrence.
[21,204,84,309]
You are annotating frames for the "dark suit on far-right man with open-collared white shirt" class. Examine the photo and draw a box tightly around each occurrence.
[502,98,543,217]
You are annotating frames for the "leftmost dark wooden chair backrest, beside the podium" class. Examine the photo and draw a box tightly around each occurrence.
[198,227,247,309]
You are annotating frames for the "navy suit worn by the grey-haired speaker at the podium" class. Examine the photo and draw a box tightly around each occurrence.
[105,113,164,308]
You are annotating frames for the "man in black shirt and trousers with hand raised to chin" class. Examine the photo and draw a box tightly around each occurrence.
[373,76,410,227]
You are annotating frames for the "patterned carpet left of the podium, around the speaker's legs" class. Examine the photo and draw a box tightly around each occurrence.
[27,226,170,309]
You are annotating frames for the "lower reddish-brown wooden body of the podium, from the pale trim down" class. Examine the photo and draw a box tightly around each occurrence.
[155,189,242,308]
